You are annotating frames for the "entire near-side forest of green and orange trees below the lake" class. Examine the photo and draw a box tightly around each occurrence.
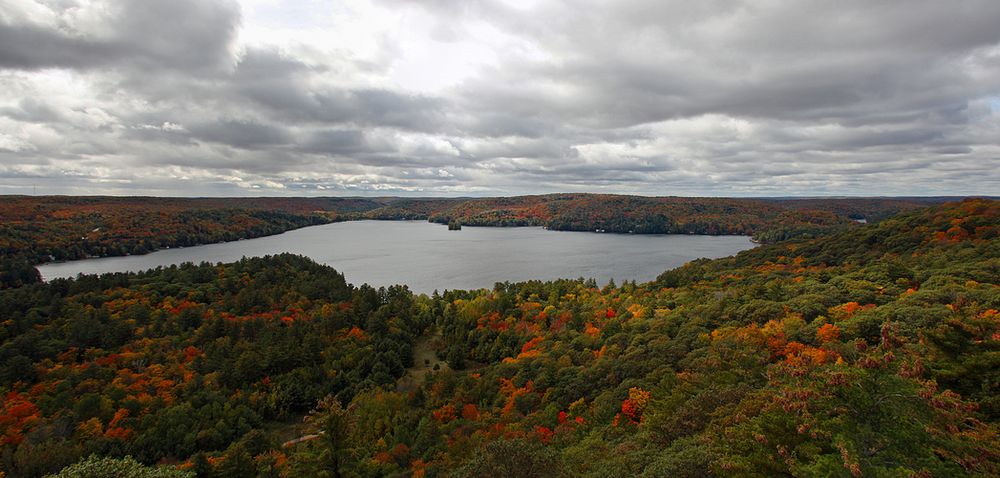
[0,200,1000,477]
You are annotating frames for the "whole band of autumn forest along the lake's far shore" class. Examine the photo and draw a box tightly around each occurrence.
[0,194,960,287]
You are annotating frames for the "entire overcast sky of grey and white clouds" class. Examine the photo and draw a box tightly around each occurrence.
[0,0,1000,196]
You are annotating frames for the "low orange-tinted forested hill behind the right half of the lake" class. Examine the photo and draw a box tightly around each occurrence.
[429,194,935,242]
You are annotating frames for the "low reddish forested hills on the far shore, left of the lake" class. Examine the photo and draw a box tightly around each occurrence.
[0,196,390,288]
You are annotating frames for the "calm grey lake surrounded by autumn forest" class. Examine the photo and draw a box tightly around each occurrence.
[38,221,754,293]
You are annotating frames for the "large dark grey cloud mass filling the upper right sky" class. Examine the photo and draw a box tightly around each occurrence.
[444,1,1000,127]
